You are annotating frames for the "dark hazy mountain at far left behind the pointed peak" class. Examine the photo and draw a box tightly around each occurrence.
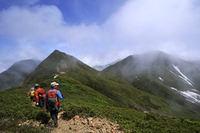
[0,59,40,90]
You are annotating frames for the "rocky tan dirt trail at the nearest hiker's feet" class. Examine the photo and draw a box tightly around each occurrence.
[49,112,124,133]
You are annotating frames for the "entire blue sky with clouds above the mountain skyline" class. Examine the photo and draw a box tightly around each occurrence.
[0,0,200,72]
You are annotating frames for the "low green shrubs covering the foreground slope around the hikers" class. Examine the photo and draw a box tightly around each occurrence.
[0,76,200,133]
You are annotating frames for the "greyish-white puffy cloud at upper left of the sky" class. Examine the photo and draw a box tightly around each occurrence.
[0,6,63,40]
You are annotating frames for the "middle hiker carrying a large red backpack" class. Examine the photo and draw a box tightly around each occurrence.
[34,84,46,107]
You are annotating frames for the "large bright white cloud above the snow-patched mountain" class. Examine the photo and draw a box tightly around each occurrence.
[100,0,200,59]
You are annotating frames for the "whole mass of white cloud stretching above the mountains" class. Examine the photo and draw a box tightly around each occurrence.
[0,0,200,72]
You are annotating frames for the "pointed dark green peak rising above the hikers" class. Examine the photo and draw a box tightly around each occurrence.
[24,50,97,84]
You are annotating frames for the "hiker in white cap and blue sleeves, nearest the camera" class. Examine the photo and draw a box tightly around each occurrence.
[46,82,63,127]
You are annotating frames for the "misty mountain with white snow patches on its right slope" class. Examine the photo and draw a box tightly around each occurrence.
[103,51,200,104]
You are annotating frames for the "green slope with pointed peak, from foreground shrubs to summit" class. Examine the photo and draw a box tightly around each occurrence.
[0,50,200,133]
